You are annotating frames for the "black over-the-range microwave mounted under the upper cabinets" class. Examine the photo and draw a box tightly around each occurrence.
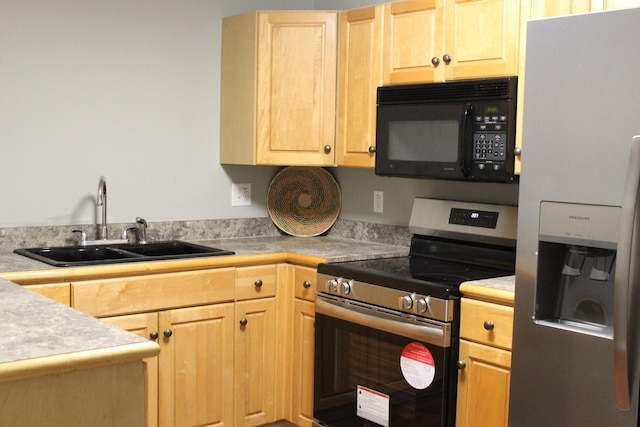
[375,77,518,183]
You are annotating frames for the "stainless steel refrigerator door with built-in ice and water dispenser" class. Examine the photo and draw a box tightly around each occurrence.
[509,9,640,427]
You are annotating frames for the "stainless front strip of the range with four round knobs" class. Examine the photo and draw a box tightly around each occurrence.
[318,273,455,322]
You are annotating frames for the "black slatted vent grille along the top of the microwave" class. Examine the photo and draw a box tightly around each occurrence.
[378,77,517,105]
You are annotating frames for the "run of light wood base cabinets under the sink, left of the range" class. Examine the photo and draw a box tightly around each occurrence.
[66,264,316,427]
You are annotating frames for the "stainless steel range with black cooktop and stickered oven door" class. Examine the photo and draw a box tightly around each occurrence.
[314,199,517,427]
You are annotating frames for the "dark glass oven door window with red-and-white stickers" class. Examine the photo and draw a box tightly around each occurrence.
[314,314,455,427]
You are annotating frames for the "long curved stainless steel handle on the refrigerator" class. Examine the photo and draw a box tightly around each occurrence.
[613,135,640,410]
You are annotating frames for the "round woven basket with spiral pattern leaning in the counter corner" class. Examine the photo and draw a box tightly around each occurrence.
[267,166,342,237]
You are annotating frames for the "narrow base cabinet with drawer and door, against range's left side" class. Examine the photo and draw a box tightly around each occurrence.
[292,266,317,427]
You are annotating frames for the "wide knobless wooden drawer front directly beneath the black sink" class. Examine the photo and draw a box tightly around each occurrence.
[71,268,235,317]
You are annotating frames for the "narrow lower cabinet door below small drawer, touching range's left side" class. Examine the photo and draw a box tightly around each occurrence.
[293,299,315,427]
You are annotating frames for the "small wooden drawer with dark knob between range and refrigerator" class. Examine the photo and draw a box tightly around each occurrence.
[460,298,513,349]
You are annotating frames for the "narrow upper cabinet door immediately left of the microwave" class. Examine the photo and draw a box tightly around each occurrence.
[336,5,382,167]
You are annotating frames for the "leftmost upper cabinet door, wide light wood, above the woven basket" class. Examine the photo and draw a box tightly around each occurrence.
[256,12,337,166]
